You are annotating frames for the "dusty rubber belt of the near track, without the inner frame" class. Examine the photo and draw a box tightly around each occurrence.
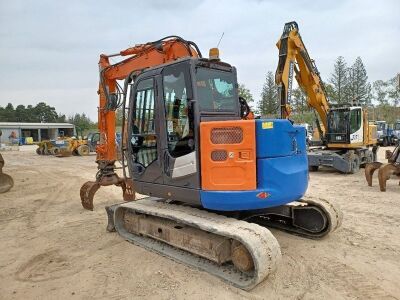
[108,197,282,290]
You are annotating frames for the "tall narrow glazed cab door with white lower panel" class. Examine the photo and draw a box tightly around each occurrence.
[160,62,199,190]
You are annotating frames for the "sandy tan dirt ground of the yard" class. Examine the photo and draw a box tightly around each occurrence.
[0,146,400,299]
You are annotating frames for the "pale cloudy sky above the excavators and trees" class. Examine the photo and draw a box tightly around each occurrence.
[0,0,400,120]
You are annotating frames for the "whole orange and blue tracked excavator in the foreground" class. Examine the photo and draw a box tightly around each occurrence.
[81,32,341,290]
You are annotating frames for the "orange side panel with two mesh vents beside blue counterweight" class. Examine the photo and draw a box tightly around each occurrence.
[200,120,257,191]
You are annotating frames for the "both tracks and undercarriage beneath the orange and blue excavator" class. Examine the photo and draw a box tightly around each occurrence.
[106,197,342,290]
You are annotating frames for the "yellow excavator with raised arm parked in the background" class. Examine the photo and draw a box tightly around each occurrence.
[275,22,378,173]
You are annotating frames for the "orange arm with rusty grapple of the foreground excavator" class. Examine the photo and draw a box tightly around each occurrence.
[80,36,201,210]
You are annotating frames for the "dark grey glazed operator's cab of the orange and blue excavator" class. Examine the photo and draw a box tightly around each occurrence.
[126,58,244,204]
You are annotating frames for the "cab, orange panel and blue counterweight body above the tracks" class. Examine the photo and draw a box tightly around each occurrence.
[125,58,308,211]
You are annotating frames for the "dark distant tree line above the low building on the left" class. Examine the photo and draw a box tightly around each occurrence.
[0,102,97,136]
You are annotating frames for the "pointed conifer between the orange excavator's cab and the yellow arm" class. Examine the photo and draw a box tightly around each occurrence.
[258,71,279,116]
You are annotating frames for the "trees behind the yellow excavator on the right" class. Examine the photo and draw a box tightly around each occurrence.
[239,56,400,123]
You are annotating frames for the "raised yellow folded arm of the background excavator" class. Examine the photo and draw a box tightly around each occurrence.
[275,22,329,136]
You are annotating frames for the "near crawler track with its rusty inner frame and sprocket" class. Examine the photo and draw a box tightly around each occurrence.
[106,197,281,290]
